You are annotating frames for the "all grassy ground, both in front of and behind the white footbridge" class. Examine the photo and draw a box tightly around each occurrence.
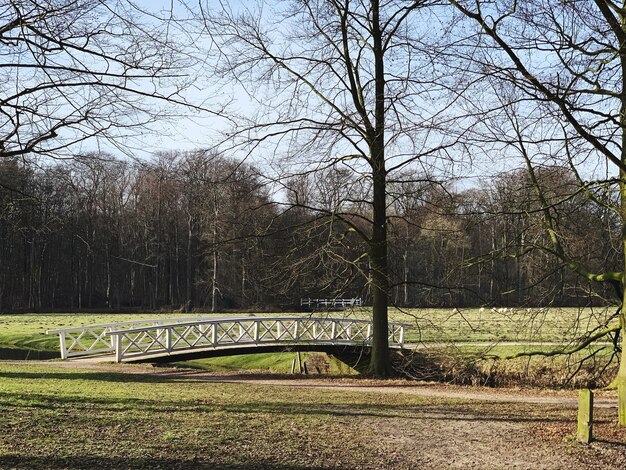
[0,309,626,470]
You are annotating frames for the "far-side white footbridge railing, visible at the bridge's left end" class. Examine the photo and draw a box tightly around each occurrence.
[46,316,207,359]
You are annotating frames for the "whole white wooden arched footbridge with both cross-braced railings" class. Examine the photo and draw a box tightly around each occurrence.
[47,316,404,362]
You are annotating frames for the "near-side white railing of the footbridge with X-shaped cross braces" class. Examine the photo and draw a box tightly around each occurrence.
[106,317,404,362]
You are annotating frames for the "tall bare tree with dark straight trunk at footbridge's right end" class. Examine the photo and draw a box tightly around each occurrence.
[203,0,455,375]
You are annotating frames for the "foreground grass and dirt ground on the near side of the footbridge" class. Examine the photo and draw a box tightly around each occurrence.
[0,363,626,469]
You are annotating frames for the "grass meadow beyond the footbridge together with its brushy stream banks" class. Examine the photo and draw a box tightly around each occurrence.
[0,308,613,386]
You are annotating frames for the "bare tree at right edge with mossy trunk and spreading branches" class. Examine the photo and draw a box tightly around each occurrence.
[450,0,626,425]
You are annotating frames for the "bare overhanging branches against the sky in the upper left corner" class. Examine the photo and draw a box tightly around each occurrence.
[0,0,195,158]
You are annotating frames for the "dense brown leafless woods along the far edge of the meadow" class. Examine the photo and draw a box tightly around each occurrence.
[0,152,620,312]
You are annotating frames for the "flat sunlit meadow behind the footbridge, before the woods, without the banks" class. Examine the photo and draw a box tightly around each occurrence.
[0,308,612,350]
